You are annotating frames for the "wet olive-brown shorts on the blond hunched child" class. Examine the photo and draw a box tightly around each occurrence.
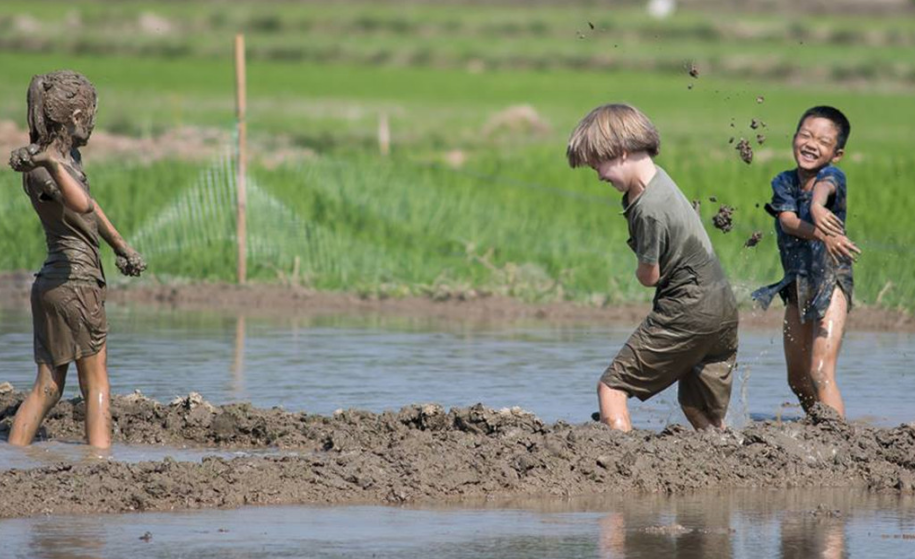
[600,317,737,418]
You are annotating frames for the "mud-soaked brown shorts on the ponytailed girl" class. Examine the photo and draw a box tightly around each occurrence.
[32,278,108,367]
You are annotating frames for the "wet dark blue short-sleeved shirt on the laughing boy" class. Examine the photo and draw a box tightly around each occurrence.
[752,165,854,322]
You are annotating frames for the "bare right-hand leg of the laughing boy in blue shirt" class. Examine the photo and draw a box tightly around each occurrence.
[810,288,848,417]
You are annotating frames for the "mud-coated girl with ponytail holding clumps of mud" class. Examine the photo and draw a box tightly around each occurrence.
[9,70,146,448]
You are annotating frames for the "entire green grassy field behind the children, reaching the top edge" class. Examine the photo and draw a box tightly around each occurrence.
[0,1,915,308]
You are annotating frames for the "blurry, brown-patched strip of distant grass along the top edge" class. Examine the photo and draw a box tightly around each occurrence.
[0,0,915,85]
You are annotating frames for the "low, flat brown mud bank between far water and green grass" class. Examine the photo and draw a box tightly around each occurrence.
[0,272,915,332]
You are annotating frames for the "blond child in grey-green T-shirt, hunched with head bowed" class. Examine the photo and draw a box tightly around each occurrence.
[566,104,738,431]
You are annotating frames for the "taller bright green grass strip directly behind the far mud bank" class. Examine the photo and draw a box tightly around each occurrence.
[0,145,915,307]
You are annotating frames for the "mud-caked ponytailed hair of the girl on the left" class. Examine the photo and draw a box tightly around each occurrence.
[26,70,98,145]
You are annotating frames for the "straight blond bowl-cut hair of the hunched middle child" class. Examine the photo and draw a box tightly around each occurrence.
[566,103,661,168]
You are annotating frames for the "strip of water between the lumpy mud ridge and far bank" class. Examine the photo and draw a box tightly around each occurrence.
[0,308,915,430]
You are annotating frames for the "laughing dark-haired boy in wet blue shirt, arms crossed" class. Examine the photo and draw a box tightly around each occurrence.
[753,106,861,416]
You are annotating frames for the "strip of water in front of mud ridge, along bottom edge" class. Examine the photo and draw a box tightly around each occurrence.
[0,490,915,559]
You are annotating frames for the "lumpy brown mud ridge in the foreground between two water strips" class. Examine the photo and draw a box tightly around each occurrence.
[0,391,915,518]
